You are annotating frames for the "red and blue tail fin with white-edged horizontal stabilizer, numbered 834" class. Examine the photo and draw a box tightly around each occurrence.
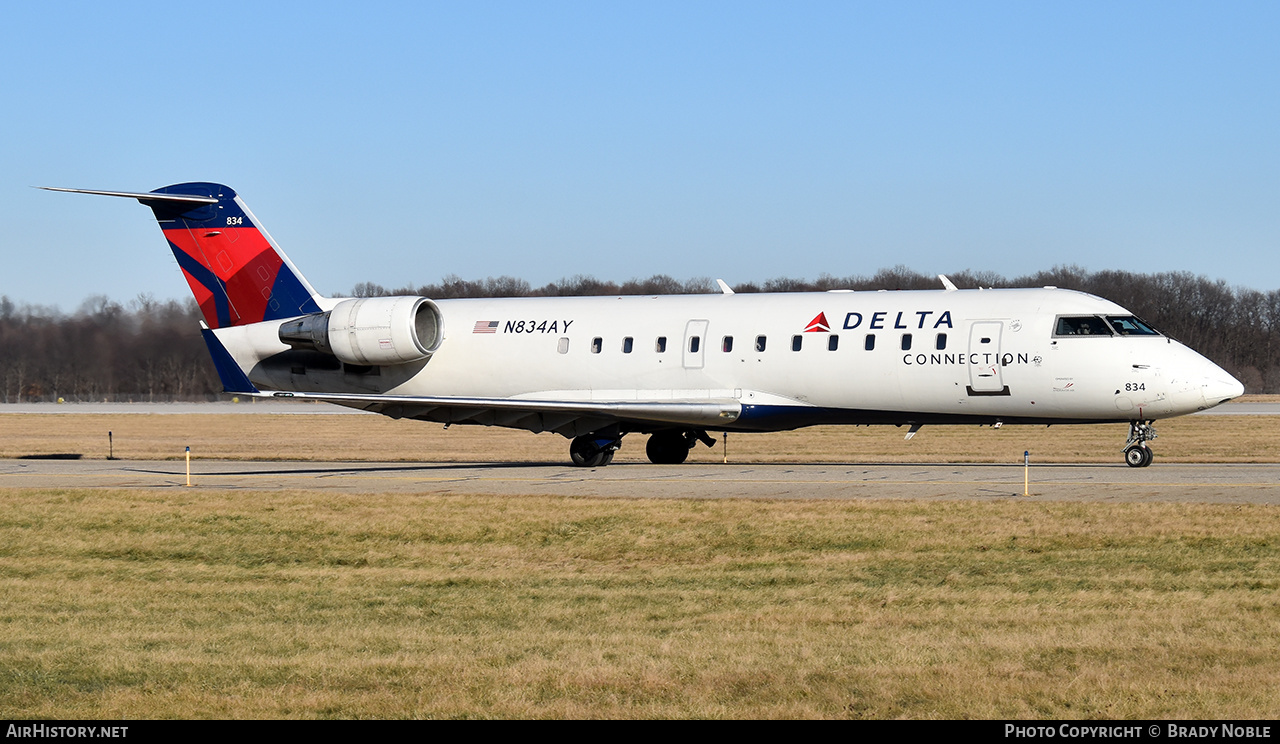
[42,183,320,328]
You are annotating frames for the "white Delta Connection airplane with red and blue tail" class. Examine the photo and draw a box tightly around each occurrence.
[42,183,1244,467]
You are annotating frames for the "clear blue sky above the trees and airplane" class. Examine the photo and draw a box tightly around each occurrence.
[0,0,1280,310]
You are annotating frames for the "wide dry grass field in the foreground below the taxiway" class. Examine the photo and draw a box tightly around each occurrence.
[0,489,1280,718]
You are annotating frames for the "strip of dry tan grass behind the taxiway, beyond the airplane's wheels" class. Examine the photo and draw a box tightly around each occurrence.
[0,414,1280,464]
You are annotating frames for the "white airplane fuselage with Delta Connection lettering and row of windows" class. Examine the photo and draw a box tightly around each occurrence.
[225,288,1243,430]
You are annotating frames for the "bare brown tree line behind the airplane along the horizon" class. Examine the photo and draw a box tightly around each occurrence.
[0,266,1280,403]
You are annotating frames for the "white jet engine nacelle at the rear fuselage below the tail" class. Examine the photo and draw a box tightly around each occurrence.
[279,297,443,366]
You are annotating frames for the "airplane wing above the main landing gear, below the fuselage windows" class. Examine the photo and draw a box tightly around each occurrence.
[250,392,742,437]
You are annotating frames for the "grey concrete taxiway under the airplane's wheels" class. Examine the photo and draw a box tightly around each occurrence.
[0,460,1280,503]
